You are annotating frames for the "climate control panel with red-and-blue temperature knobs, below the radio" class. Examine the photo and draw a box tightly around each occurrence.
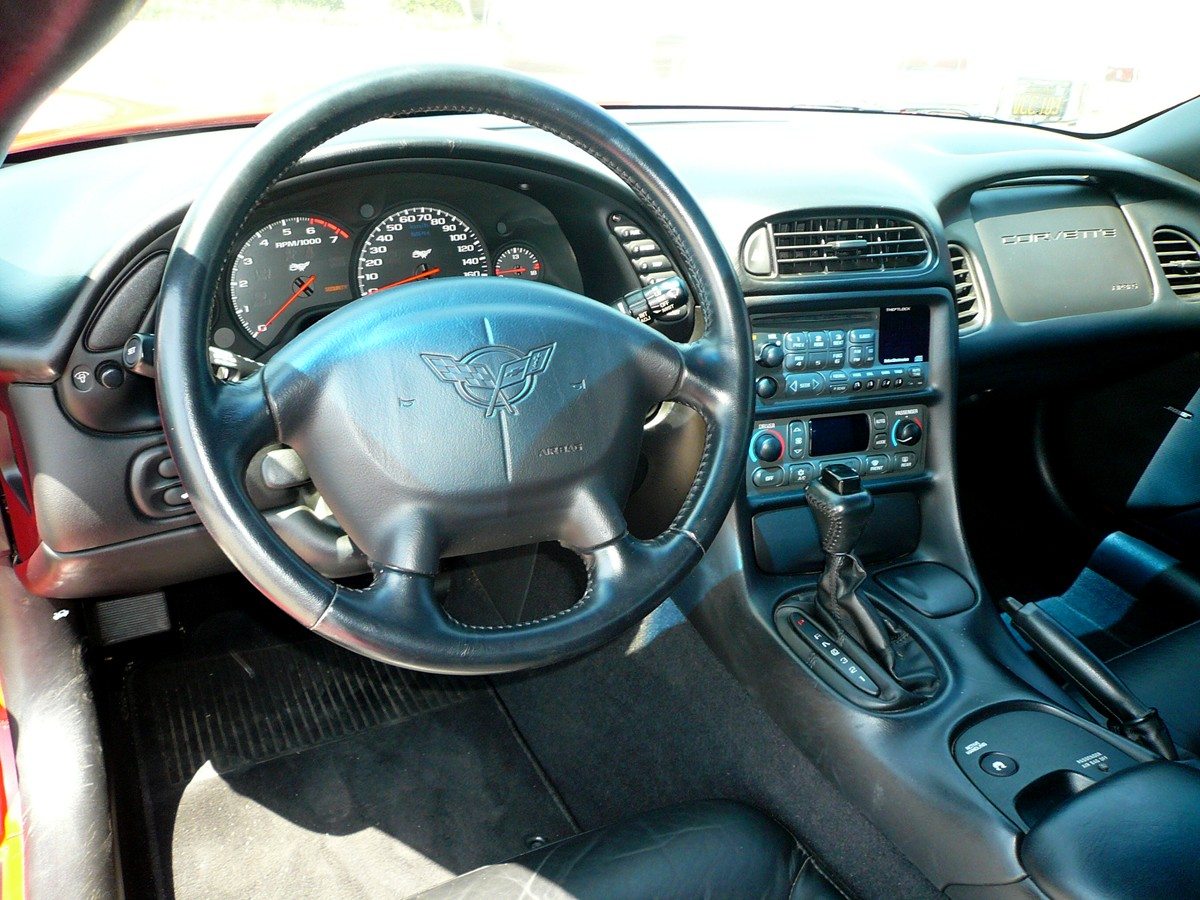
[746,404,929,496]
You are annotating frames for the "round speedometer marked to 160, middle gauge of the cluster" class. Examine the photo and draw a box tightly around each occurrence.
[358,206,491,294]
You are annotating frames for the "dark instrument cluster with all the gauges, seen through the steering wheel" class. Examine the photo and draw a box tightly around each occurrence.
[220,172,582,358]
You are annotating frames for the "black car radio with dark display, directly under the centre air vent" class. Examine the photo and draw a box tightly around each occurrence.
[751,305,929,407]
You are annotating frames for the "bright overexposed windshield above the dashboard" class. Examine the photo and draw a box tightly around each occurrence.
[14,0,1200,149]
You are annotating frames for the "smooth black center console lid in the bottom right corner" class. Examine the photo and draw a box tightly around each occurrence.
[1020,762,1200,900]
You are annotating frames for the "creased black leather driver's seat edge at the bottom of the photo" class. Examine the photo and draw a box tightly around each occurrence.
[419,800,842,900]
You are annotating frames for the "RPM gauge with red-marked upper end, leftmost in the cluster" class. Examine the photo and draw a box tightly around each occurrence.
[229,216,352,347]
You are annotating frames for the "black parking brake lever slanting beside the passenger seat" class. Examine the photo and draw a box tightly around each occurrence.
[1001,596,1178,760]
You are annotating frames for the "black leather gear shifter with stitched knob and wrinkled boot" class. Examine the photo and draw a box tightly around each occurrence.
[805,463,895,672]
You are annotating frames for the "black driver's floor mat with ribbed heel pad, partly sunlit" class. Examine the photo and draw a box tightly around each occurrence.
[122,641,575,899]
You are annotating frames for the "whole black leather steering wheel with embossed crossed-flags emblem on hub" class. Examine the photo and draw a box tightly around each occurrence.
[157,67,752,674]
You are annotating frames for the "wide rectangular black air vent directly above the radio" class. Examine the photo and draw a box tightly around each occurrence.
[772,216,930,277]
